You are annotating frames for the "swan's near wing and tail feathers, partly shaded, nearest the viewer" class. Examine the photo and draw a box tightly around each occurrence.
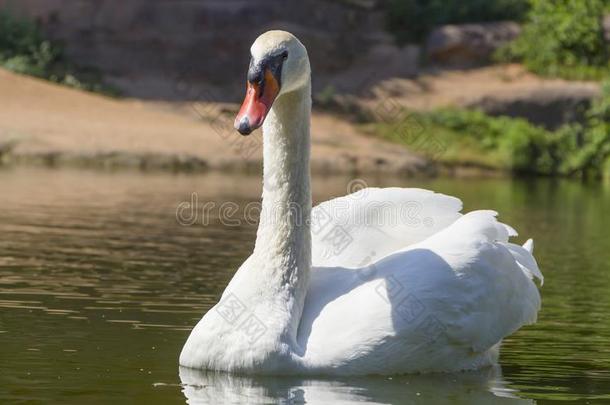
[299,211,541,373]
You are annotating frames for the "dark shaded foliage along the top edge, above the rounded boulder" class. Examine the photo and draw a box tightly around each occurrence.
[386,0,528,43]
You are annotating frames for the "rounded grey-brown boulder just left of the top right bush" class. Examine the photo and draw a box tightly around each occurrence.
[426,21,521,67]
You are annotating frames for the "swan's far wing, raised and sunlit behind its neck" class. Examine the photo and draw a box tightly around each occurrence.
[311,187,462,268]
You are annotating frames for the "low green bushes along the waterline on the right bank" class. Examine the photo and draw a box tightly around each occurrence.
[374,82,610,178]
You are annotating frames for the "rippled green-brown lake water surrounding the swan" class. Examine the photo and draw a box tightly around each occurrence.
[0,169,610,404]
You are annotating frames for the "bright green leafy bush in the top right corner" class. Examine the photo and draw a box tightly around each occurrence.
[498,0,610,79]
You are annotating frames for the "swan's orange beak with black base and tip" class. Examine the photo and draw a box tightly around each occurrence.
[234,69,280,135]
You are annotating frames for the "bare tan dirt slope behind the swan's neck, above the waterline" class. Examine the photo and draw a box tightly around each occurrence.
[0,69,426,173]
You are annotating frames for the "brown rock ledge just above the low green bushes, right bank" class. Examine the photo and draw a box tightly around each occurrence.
[468,81,600,130]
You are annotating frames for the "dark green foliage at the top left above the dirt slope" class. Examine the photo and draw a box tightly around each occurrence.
[0,10,118,96]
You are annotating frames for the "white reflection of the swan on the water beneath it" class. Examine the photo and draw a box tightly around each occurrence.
[180,366,533,405]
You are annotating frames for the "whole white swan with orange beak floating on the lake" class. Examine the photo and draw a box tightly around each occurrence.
[180,31,542,374]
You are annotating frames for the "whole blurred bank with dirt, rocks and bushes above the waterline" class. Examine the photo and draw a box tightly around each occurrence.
[0,0,610,178]
